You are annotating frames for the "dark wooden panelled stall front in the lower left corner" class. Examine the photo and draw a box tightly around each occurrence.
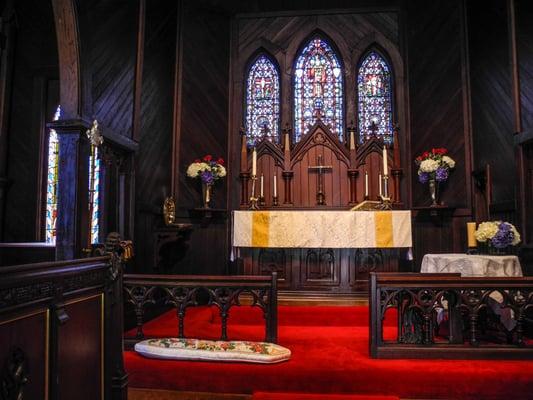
[0,254,127,400]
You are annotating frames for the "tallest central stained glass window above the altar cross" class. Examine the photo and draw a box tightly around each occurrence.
[294,37,343,141]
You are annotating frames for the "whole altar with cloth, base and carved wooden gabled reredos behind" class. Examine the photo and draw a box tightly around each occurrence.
[231,120,412,297]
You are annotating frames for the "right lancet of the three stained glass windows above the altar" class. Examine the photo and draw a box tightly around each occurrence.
[357,51,392,143]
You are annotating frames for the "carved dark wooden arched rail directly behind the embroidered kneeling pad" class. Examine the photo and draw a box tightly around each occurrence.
[124,272,278,348]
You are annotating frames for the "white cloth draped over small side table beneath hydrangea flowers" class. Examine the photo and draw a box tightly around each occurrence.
[420,254,523,277]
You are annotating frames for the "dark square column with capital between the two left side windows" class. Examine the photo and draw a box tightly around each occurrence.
[48,120,89,260]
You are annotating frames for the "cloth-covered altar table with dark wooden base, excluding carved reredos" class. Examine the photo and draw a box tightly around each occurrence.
[232,210,412,295]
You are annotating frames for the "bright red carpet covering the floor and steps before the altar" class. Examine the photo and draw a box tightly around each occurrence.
[125,306,533,400]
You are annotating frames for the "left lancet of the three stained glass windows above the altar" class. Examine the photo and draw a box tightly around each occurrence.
[246,54,280,145]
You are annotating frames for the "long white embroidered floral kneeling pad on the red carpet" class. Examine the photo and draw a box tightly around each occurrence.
[135,338,291,364]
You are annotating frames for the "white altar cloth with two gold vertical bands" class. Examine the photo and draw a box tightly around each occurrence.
[233,210,412,248]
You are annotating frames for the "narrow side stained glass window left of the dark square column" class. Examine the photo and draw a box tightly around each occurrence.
[45,106,61,243]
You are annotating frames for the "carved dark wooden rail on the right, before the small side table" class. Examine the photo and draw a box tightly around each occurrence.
[369,272,533,359]
